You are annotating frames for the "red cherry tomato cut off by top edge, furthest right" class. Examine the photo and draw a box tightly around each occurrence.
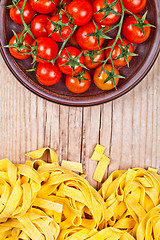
[123,0,147,13]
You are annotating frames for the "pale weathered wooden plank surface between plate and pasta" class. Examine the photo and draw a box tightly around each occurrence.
[0,56,160,187]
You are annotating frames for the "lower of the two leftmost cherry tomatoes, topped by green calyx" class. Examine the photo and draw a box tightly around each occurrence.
[9,33,34,59]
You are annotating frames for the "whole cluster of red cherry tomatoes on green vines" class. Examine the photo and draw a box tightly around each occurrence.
[8,0,151,93]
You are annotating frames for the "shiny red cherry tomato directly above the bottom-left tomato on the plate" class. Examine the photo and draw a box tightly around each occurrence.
[32,37,58,63]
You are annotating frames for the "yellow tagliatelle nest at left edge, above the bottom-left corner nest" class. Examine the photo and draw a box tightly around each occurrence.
[0,159,41,222]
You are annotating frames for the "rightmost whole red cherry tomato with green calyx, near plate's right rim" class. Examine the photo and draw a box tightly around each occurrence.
[122,15,151,43]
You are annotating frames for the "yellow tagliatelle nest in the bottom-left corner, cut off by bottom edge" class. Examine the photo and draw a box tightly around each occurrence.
[0,208,60,240]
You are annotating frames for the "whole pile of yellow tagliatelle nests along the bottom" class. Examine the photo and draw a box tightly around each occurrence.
[0,145,160,240]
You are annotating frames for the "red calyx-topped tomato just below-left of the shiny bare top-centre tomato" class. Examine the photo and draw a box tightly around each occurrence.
[47,15,71,42]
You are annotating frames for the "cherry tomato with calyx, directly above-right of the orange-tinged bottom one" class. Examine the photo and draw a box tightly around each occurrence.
[105,39,133,67]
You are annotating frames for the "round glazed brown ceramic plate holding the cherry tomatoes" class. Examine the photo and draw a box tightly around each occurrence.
[0,0,160,106]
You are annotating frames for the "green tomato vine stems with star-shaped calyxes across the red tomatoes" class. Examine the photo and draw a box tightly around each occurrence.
[5,0,153,88]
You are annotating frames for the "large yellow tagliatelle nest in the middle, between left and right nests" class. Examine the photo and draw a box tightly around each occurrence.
[26,149,106,234]
